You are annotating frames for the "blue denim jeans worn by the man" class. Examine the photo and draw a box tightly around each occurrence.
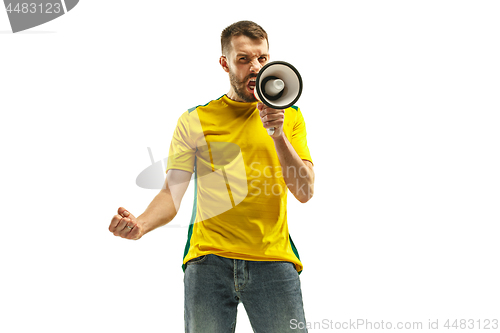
[184,254,307,333]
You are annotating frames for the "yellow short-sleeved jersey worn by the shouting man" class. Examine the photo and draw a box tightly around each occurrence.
[167,95,312,274]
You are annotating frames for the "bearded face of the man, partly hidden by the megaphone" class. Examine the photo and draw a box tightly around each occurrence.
[221,36,269,102]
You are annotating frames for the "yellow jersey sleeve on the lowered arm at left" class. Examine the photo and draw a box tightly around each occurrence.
[166,111,196,172]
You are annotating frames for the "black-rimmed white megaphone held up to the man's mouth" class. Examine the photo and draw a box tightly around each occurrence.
[253,61,302,135]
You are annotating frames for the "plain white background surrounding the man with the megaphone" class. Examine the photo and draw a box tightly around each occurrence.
[0,0,500,333]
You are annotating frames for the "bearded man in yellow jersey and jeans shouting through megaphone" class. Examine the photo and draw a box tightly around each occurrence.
[109,21,314,333]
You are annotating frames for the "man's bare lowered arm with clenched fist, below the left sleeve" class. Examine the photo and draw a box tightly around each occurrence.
[109,169,192,240]
